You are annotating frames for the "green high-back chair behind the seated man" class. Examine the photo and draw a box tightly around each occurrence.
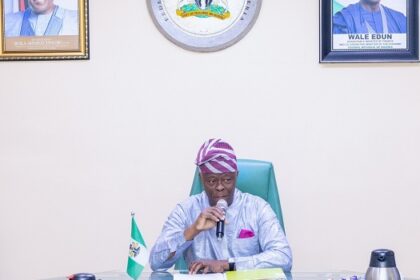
[175,159,285,270]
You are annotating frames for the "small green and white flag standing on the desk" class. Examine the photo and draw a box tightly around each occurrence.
[127,213,149,279]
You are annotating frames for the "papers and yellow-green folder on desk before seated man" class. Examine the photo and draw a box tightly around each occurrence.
[174,268,286,280]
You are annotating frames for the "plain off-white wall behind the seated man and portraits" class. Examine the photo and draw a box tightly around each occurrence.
[0,0,420,280]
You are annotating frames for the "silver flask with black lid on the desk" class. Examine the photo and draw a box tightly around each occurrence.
[366,249,401,280]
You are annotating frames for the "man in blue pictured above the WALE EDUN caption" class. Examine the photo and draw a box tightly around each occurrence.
[333,0,407,34]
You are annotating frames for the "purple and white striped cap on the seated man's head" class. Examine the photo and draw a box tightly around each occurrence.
[195,139,238,173]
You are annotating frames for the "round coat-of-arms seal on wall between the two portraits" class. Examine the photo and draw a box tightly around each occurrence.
[146,0,262,52]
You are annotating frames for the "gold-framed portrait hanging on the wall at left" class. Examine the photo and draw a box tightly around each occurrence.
[0,0,89,61]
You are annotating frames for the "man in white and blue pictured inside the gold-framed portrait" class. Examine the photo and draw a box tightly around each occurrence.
[5,0,79,37]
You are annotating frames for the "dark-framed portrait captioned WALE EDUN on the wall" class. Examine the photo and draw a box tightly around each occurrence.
[319,0,419,63]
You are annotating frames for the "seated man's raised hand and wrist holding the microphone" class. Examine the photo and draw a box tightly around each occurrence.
[184,207,225,240]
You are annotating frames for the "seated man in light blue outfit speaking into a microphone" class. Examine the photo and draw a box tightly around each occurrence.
[150,139,292,274]
